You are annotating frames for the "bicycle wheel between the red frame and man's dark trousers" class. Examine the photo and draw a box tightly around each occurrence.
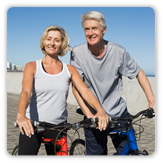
[70,139,86,156]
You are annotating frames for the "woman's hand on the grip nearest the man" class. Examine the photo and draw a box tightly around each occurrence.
[93,110,109,131]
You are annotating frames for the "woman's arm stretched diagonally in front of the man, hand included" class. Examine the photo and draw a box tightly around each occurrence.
[68,66,109,130]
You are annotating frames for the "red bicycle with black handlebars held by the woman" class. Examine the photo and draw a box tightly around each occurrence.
[12,118,97,156]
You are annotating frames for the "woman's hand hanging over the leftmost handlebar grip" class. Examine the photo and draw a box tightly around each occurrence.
[16,113,34,137]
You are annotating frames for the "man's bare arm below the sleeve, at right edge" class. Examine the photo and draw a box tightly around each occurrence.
[137,69,155,112]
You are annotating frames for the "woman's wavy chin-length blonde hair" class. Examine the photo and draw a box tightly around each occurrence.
[40,25,72,57]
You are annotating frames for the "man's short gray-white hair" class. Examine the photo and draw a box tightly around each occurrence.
[81,11,106,30]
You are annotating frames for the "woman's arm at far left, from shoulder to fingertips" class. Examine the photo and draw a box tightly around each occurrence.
[17,62,36,137]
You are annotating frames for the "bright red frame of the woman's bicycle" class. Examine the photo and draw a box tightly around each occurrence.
[41,135,68,156]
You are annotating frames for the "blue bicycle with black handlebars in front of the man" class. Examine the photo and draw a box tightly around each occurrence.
[73,108,155,156]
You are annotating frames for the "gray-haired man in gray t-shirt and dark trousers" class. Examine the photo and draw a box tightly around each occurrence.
[71,11,155,155]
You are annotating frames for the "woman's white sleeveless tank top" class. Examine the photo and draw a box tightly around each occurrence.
[26,59,71,125]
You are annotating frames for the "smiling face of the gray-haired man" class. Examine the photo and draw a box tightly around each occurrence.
[84,19,106,45]
